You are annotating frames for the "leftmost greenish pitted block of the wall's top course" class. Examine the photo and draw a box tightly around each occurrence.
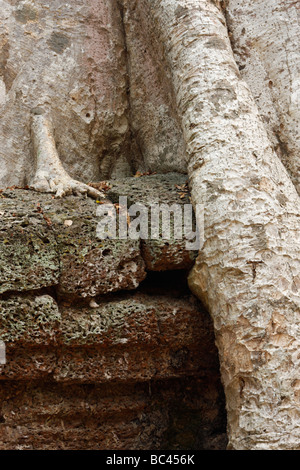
[0,191,59,293]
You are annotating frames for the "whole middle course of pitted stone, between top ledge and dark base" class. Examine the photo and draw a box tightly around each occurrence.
[0,294,218,383]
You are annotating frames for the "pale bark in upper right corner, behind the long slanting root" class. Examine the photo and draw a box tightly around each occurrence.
[226,0,300,192]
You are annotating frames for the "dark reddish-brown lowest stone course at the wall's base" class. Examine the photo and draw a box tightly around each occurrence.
[0,376,226,450]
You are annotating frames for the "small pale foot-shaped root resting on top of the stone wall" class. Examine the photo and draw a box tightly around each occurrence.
[30,115,105,199]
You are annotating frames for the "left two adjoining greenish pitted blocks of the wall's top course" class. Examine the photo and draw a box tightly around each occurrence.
[0,189,146,297]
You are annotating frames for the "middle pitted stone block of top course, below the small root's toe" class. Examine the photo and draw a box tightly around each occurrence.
[47,198,146,297]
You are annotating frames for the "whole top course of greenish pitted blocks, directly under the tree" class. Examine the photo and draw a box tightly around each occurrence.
[0,174,197,297]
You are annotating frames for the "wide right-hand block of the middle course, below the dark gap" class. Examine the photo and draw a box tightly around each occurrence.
[54,294,218,382]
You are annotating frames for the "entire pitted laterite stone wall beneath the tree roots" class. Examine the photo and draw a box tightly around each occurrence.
[0,174,226,450]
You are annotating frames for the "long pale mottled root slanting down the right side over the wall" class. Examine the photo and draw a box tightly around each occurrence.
[138,0,300,449]
